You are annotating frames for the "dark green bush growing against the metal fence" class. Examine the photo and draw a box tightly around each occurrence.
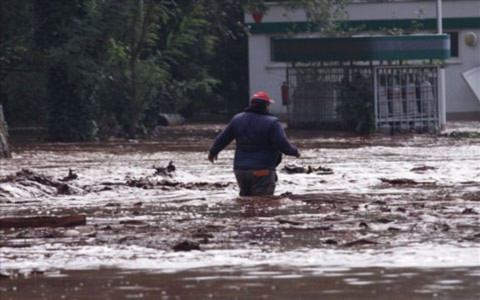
[337,71,375,133]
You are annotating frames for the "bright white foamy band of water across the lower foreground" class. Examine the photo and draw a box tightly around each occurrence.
[0,244,480,273]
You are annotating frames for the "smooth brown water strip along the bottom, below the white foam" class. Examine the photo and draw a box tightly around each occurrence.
[0,267,480,300]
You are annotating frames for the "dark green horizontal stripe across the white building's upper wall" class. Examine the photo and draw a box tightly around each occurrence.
[247,17,480,34]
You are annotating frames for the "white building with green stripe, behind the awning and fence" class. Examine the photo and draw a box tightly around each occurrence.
[245,0,480,120]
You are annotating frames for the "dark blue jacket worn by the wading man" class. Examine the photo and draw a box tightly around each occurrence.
[210,107,298,170]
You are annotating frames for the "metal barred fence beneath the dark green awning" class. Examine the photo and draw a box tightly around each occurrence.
[287,64,438,131]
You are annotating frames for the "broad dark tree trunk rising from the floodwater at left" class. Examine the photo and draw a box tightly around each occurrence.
[34,0,101,141]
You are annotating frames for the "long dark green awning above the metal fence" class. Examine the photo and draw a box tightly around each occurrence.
[272,34,450,62]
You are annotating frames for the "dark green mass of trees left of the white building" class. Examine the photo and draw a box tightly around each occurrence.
[0,0,346,141]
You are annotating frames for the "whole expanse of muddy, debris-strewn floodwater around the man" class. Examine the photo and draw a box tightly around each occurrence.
[0,123,480,299]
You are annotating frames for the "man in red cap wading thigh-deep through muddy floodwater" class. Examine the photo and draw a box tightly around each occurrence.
[208,92,300,196]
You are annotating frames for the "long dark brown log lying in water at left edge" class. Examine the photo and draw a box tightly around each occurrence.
[0,215,87,229]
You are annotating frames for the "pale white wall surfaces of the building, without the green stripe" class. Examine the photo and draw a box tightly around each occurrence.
[245,0,480,119]
